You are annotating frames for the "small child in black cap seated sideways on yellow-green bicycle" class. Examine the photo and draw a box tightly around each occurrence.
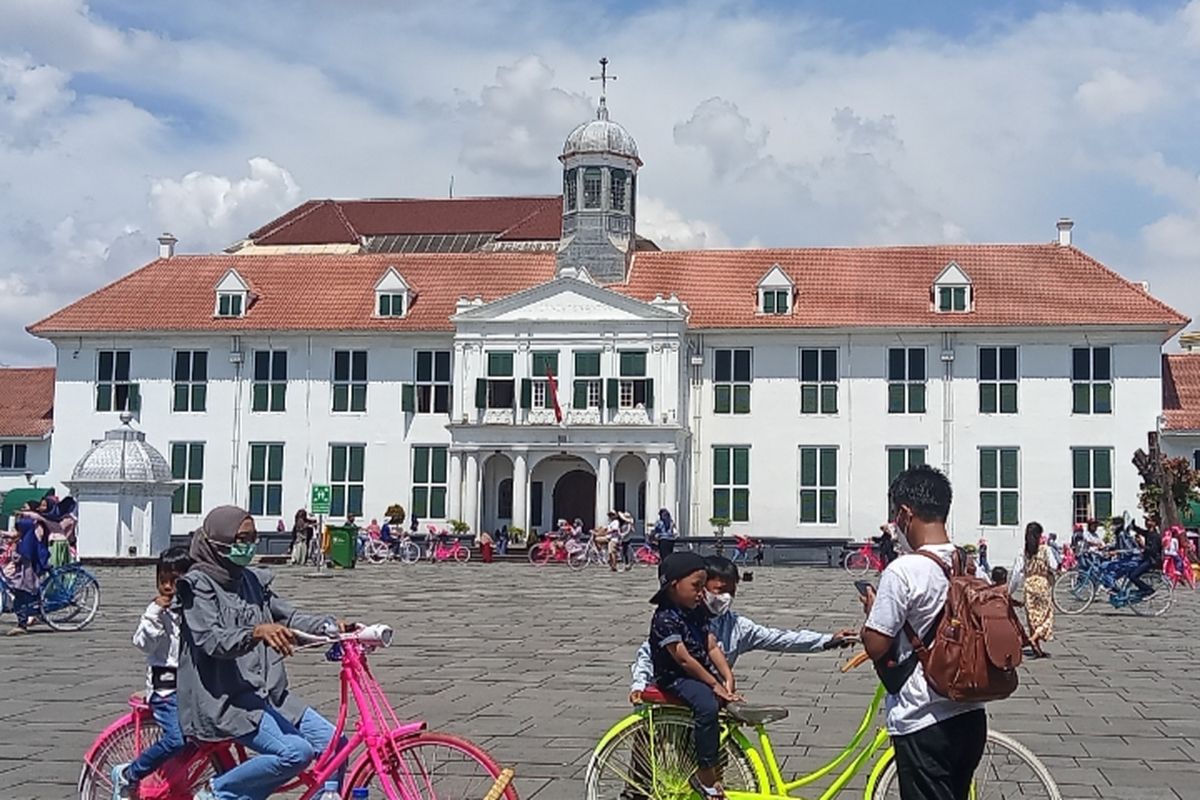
[650,552,740,799]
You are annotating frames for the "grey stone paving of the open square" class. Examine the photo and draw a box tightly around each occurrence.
[0,563,1200,800]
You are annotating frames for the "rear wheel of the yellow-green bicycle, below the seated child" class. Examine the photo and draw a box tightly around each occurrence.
[583,709,767,800]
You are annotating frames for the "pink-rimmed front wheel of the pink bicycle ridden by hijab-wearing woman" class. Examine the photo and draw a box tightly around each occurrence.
[344,732,517,800]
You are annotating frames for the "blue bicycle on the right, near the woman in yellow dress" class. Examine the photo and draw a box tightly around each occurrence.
[1050,553,1172,616]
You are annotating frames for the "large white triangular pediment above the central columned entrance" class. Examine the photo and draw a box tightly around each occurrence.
[455,277,682,323]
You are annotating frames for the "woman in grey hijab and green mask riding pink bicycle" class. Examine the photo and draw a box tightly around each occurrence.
[175,506,344,800]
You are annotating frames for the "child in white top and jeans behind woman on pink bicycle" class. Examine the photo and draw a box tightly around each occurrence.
[110,547,192,800]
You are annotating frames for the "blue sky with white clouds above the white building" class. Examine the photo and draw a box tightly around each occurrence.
[0,0,1200,363]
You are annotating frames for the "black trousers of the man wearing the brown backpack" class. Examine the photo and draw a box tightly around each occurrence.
[892,709,988,800]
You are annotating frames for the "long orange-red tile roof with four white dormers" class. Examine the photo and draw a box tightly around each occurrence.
[29,245,1188,336]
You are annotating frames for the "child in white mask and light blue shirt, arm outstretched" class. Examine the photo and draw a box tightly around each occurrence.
[629,555,858,705]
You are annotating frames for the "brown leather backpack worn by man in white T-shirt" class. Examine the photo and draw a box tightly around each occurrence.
[904,549,1025,703]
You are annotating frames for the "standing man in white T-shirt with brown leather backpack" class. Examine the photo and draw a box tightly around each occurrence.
[862,465,1021,800]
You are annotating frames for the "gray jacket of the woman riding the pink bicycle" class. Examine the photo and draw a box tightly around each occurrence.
[175,569,336,741]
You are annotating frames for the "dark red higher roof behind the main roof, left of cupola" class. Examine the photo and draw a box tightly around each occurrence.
[250,196,563,245]
